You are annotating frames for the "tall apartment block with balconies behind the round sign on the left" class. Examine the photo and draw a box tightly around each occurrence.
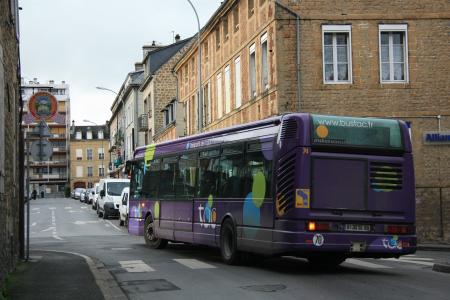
[21,78,70,197]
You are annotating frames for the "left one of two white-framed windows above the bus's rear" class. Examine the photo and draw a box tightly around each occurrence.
[322,25,352,83]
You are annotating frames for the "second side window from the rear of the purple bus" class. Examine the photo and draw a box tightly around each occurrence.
[219,144,245,198]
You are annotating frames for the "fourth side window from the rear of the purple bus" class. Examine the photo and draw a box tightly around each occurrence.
[175,153,198,199]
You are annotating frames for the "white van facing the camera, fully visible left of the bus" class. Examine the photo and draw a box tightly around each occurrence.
[97,178,130,219]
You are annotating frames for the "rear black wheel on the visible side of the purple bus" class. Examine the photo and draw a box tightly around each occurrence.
[220,219,240,265]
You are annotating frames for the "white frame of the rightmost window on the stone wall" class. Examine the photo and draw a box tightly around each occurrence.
[378,24,409,84]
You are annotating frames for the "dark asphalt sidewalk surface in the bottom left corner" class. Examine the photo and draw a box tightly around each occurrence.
[7,251,104,300]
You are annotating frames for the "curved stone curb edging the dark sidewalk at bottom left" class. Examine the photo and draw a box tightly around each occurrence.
[33,249,128,300]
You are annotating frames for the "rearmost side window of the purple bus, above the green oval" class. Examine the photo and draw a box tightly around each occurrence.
[244,142,273,198]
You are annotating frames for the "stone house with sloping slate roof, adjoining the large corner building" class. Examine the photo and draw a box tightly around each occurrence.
[138,35,191,144]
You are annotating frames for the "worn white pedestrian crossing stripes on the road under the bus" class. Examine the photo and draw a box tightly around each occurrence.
[119,255,434,273]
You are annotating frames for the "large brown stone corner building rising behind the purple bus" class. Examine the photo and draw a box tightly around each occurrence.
[175,0,450,243]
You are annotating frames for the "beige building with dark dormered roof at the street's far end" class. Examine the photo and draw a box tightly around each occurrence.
[70,122,109,190]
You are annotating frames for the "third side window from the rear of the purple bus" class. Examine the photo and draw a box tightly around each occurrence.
[197,149,220,198]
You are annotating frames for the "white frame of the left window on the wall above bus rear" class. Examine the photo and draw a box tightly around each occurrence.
[322,25,353,84]
